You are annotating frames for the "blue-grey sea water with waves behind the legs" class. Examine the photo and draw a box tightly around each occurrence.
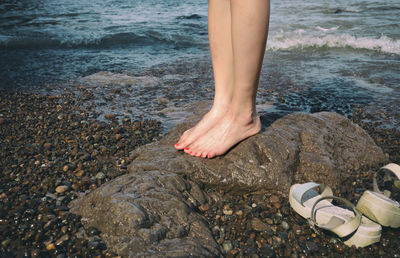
[0,0,400,129]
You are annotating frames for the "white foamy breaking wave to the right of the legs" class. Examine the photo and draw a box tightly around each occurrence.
[267,32,400,55]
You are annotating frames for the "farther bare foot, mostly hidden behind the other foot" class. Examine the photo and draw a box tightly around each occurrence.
[175,107,228,150]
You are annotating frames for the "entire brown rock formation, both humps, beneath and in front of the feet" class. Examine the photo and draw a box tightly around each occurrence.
[71,112,386,257]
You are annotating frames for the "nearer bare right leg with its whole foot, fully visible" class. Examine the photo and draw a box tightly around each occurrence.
[185,0,269,158]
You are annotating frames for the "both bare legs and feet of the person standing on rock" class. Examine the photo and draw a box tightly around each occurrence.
[175,0,270,158]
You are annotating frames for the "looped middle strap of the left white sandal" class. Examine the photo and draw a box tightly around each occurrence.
[310,196,362,237]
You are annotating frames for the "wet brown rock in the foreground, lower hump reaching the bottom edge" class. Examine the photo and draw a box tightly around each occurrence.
[70,171,221,257]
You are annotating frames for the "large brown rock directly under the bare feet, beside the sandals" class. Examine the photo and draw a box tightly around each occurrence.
[129,112,386,192]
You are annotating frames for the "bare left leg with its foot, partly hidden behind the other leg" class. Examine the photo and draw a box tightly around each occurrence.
[175,0,233,150]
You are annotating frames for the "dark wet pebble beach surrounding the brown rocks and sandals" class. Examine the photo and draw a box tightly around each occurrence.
[0,83,400,257]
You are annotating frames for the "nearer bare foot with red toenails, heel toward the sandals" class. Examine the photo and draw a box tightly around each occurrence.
[185,113,261,158]
